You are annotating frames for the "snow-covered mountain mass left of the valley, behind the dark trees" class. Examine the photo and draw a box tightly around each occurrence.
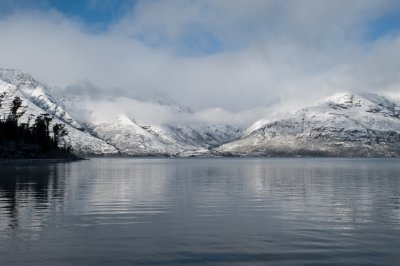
[0,69,243,156]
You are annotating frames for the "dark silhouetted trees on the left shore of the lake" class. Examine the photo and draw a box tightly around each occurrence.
[0,94,71,157]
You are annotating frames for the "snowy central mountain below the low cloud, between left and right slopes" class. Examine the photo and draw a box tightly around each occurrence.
[84,114,242,156]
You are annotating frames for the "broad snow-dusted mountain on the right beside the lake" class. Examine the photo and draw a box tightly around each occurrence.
[216,93,400,157]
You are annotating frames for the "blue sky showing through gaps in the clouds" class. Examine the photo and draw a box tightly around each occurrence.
[0,0,400,56]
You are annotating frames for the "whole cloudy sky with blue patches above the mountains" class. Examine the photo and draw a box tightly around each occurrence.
[0,0,400,116]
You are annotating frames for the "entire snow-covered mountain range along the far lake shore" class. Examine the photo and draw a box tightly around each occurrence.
[0,69,400,157]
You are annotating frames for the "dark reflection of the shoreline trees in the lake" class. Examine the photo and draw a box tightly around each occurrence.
[0,164,69,239]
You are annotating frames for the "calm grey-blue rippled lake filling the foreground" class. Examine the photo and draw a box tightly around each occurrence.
[0,158,400,265]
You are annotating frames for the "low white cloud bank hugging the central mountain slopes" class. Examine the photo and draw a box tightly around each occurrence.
[74,97,282,127]
